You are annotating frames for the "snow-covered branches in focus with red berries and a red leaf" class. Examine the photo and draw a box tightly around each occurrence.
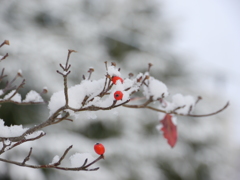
[0,41,229,171]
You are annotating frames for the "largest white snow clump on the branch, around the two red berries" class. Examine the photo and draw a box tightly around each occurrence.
[48,74,133,115]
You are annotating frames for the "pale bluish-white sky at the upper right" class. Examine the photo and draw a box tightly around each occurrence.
[162,0,240,145]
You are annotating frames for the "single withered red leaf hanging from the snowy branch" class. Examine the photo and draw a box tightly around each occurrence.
[160,114,178,148]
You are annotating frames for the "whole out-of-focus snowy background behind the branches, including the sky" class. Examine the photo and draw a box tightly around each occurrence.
[0,0,237,180]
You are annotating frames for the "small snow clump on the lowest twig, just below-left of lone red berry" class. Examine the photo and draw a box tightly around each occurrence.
[69,153,94,168]
